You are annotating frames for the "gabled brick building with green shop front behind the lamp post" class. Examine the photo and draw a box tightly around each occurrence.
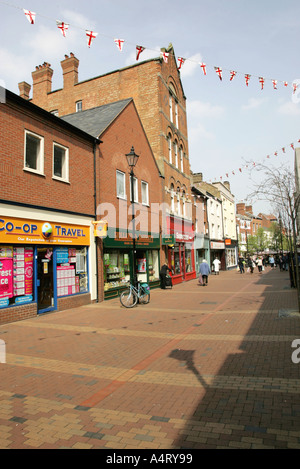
[63,99,163,299]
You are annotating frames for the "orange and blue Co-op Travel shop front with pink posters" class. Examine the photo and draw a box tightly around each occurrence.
[0,215,91,320]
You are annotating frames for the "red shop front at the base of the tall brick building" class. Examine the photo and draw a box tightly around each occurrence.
[162,217,196,285]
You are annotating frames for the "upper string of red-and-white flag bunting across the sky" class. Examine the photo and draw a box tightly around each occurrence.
[0,0,300,94]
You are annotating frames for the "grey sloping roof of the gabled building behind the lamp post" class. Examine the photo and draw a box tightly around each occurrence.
[61,98,133,138]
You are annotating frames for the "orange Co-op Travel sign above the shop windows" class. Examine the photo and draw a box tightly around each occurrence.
[0,215,90,246]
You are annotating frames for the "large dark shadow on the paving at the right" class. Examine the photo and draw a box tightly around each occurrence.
[169,270,300,449]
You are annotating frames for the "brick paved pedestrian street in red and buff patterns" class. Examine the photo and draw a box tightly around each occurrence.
[0,269,300,450]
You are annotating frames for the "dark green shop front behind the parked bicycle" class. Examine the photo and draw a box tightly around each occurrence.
[103,228,160,299]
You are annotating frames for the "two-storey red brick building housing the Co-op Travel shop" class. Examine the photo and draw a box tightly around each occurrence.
[0,91,99,323]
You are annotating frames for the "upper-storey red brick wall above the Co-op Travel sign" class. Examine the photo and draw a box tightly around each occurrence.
[0,94,94,214]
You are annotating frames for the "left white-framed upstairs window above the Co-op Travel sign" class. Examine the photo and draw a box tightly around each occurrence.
[24,130,44,174]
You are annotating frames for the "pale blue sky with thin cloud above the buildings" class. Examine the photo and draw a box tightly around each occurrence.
[0,0,300,214]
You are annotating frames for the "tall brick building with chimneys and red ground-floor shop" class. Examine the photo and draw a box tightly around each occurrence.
[19,45,195,283]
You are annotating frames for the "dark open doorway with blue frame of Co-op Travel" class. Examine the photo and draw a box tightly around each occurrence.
[37,248,54,313]
